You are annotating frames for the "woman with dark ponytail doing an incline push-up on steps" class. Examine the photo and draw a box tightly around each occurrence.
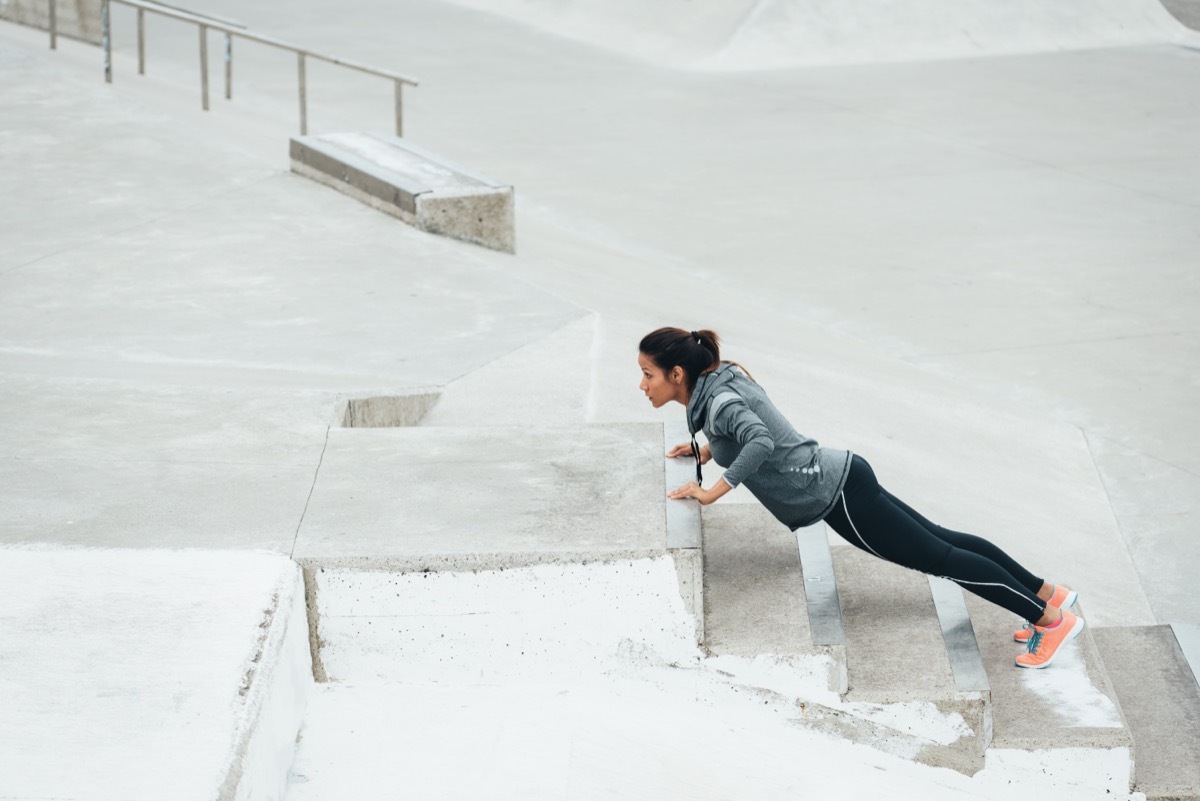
[637,329,1084,668]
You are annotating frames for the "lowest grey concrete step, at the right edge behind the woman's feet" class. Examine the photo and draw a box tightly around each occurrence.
[1092,626,1200,801]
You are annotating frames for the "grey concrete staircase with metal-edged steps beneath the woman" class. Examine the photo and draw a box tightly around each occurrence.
[703,504,1200,800]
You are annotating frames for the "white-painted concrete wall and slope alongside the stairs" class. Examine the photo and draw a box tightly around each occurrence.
[287,558,1128,801]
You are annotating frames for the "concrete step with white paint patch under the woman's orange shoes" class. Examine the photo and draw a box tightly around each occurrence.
[966,594,1133,795]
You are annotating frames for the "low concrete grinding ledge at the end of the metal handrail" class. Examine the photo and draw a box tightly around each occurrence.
[290,133,516,253]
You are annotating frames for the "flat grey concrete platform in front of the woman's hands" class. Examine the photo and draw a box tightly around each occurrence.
[294,423,667,571]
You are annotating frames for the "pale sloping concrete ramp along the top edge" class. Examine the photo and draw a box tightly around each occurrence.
[446,0,1194,71]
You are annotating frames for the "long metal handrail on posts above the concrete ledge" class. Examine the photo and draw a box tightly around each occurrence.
[49,0,419,137]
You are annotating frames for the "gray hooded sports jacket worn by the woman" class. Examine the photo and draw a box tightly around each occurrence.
[688,362,851,531]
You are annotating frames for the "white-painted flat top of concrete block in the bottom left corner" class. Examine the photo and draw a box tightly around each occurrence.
[0,546,306,801]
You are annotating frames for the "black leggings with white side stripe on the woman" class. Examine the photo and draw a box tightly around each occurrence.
[826,454,1045,622]
